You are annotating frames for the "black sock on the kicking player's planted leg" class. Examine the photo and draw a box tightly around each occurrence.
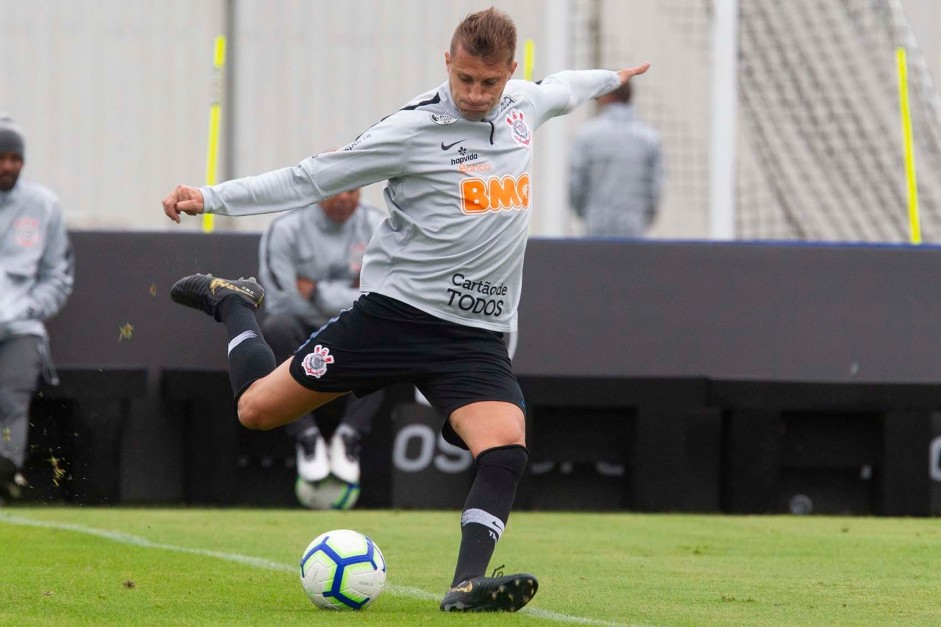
[451,445,529,586]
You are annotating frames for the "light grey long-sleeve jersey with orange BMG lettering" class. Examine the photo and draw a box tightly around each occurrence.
[200,70,620,332]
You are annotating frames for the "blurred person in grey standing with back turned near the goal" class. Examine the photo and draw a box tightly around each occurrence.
[569,83,663,237]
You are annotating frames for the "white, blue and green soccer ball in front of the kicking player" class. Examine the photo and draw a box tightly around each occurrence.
[301,529,386,610]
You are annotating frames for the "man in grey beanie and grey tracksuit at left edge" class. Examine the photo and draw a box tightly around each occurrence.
[0,114,74,500]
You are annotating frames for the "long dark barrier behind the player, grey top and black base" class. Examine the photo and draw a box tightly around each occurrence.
[27,230,941,515]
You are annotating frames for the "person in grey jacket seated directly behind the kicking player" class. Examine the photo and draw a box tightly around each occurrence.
[258,189,383,484]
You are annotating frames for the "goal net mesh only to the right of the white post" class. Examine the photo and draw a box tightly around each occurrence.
[737,0,941,242]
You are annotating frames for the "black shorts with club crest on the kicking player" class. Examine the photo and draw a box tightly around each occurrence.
[291,293,526,446]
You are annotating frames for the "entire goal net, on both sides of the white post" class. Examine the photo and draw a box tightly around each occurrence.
[575,0,941,242]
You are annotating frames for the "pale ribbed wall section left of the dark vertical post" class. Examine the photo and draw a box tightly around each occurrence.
[0,0,221,229]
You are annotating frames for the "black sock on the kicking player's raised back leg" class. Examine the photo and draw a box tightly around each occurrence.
[218,297,278,394]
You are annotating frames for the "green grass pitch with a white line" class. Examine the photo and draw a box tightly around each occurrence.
[0,507,941,625]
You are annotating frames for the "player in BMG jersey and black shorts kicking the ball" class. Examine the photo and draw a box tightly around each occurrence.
[163,8,649,611]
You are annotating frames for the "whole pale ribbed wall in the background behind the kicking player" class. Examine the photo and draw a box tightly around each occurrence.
[0,0,941,238]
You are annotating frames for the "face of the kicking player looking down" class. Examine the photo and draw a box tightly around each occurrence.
[444,45,516,120]
